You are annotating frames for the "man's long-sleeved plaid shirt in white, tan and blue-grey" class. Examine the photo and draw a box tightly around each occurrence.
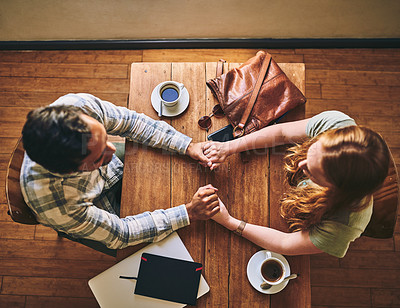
[20,94,191,249]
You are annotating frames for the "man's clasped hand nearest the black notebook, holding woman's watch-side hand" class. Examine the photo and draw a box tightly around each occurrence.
[186,184,219,221]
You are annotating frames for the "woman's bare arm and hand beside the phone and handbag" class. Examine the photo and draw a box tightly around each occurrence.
[203,119,309,170]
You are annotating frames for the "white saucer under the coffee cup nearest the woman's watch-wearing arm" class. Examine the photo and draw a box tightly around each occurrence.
[247,250,290,294]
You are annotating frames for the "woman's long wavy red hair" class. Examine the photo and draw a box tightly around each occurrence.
[280,126,390,231]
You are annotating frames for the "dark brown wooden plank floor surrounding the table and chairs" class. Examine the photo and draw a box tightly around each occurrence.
[0,49,400,308]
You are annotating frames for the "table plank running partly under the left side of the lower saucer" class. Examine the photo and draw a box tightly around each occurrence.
[216,63,269,307]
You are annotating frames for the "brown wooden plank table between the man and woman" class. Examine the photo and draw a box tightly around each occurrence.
[118,62,311,308]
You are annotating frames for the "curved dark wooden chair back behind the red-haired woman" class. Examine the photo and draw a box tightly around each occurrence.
[362,149,400,239]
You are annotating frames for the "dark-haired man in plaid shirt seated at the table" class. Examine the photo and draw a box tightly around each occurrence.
[21,94,219,255]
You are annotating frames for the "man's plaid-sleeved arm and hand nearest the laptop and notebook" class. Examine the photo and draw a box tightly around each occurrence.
[40,185,219,249]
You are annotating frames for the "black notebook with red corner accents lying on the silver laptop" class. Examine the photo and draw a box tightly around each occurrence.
[135,253,203,306]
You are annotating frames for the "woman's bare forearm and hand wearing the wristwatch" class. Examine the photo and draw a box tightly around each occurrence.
[212,200,323,255]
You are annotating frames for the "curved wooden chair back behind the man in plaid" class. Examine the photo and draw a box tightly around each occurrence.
[6,139,38,225]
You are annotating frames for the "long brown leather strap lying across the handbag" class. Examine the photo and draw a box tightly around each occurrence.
[233,53,272,138]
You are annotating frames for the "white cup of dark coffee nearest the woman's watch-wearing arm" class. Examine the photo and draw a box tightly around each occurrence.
[259,251,286,285]
